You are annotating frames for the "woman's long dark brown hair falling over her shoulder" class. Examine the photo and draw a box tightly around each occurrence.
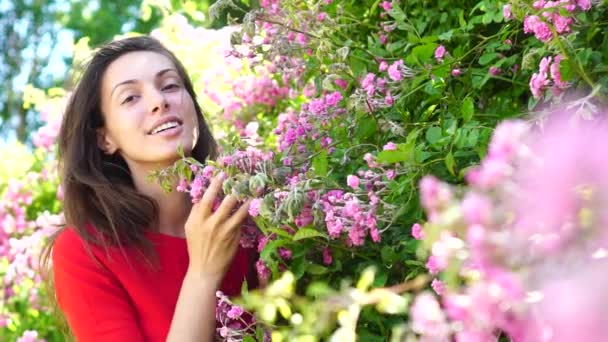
[41,36,217,336]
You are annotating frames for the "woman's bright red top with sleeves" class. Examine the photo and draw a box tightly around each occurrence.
[52,229,257,342]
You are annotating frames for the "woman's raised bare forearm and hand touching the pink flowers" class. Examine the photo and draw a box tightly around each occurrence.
[167,176,249,342]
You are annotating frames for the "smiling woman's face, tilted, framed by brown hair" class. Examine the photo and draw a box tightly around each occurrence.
[97,51,199,171]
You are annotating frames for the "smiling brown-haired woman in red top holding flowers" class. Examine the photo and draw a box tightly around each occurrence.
[49,37,257,341]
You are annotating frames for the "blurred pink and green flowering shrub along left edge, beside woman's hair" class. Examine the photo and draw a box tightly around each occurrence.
[0,90,63,342]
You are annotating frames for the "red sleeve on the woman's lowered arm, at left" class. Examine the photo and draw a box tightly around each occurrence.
[52,229,144,342]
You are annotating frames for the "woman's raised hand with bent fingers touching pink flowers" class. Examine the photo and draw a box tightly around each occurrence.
[185,175,249,286]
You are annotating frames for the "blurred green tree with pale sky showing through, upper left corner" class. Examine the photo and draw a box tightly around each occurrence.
[0,0,160,142]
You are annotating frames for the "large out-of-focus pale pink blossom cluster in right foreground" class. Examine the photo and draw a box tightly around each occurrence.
[410,113,608,341]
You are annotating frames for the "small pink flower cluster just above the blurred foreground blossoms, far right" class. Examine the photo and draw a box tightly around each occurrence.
[530,55,570,99]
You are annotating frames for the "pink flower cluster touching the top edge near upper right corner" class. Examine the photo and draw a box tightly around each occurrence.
[524,0,591,42]
